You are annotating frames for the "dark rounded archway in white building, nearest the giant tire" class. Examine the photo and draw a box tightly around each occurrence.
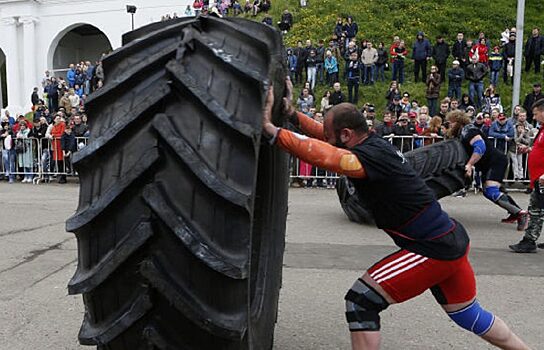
[48,23,112,76]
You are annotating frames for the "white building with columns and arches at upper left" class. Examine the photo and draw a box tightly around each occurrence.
[0,0,192,114]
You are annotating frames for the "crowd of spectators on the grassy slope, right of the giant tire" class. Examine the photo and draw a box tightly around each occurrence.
[286,16,544,187]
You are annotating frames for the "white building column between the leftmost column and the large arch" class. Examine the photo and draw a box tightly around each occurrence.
[19,17,39,107]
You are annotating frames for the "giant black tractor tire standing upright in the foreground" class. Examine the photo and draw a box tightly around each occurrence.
[66,17,288,350]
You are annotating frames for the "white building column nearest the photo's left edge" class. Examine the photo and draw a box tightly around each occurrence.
[0,17,24,115]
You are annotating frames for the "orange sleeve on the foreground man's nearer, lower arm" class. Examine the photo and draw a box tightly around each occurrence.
[276,129,366,178]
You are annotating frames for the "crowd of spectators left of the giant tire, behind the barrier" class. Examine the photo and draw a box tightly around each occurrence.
[0,61,98,183]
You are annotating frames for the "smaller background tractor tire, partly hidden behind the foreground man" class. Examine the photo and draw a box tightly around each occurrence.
[336,140,468,224]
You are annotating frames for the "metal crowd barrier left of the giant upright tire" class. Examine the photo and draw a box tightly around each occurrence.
[0,137,88,184]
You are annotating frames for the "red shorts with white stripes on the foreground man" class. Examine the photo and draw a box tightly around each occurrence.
[368,248,476,305]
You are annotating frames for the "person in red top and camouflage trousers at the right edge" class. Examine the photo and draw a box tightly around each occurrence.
[509,100,544,253]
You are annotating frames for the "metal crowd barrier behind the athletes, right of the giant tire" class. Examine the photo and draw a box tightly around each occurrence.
[290,135,532,188]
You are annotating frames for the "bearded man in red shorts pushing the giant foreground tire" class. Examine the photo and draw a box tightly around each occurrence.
[262,83,529,350]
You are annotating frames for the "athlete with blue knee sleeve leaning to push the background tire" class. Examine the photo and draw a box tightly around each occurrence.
[447,111,528,231]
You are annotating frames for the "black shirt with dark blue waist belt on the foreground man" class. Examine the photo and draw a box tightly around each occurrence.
[350,134,469,260]
